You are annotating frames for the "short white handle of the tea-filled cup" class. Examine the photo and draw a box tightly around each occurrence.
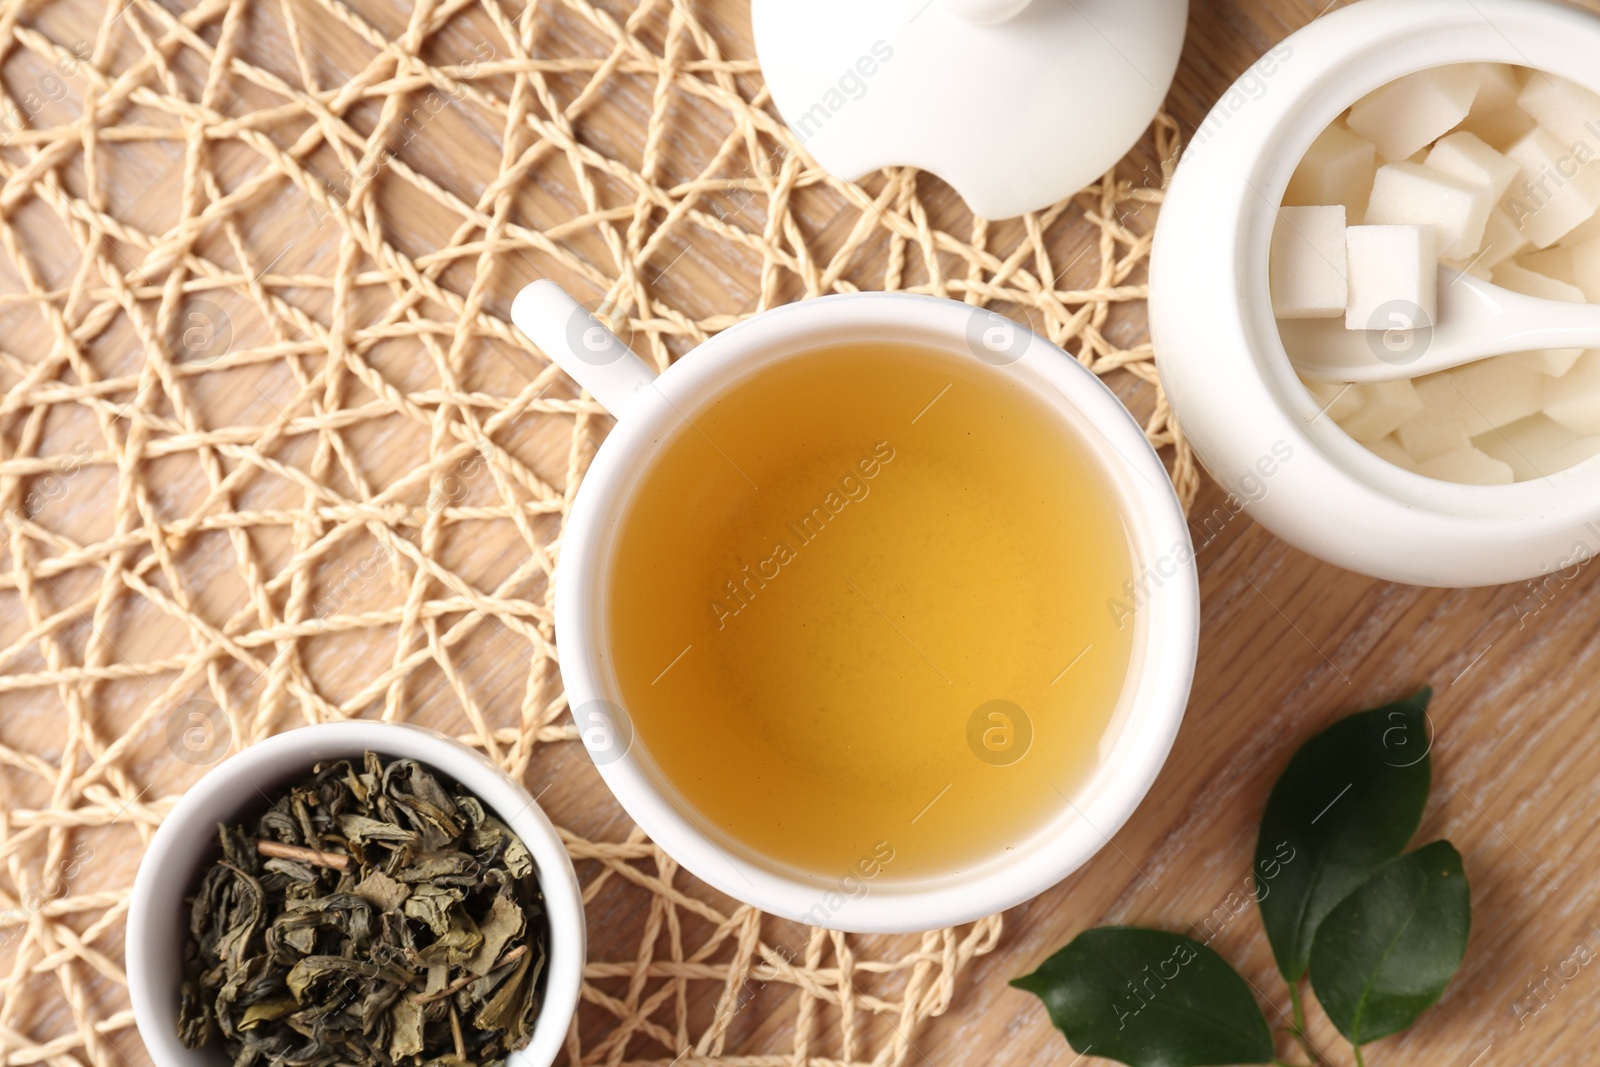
[510,278,656,418]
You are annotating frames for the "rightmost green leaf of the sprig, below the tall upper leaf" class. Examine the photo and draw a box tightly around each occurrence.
[1310,841,1472,1045]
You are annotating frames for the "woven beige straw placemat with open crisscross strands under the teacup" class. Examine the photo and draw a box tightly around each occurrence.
[0,0,1195,1067]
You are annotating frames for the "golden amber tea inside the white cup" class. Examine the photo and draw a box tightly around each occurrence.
[608,344,1134,883]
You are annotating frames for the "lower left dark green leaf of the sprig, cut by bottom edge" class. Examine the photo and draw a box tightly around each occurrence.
[1011,926,1272,1067]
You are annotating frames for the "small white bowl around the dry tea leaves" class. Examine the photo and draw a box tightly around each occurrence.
[126,721,586,1067]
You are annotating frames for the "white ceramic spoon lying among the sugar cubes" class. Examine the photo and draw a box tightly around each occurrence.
[1278,267,1600,382]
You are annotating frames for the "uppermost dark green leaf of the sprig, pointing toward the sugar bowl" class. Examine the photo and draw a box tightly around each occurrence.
[1253,688,1432,985]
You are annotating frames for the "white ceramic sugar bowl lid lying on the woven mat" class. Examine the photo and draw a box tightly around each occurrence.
[752,0,1189,219]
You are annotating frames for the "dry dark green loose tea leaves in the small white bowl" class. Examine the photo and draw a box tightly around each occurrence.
[178,752,547,1067]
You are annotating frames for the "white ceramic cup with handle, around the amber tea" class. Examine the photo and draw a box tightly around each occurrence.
[512,282,1198,933]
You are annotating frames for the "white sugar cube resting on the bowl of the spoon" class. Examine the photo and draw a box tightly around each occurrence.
[1344,226,1438,327]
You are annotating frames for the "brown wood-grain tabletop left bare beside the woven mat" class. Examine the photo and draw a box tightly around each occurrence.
[11,0,1600,1067]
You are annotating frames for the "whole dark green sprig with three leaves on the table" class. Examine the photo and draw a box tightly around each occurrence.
[1011,688,1472,1067]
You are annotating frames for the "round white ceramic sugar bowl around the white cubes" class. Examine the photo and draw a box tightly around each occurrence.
[1150,0,1600,585]
